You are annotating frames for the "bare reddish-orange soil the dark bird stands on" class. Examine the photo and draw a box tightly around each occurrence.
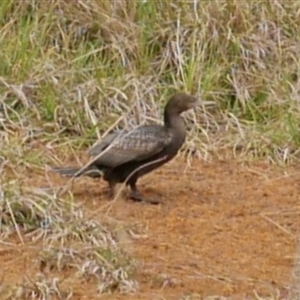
[0,158,300,300]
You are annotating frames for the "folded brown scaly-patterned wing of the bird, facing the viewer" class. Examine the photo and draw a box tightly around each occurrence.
[89,125,172,168]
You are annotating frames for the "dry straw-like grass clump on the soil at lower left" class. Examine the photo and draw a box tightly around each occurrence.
[0,175,138,299]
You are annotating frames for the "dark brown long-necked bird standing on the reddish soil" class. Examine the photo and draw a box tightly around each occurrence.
[52,93,199,204]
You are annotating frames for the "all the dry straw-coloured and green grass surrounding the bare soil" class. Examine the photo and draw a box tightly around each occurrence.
[0,0,300,299]
